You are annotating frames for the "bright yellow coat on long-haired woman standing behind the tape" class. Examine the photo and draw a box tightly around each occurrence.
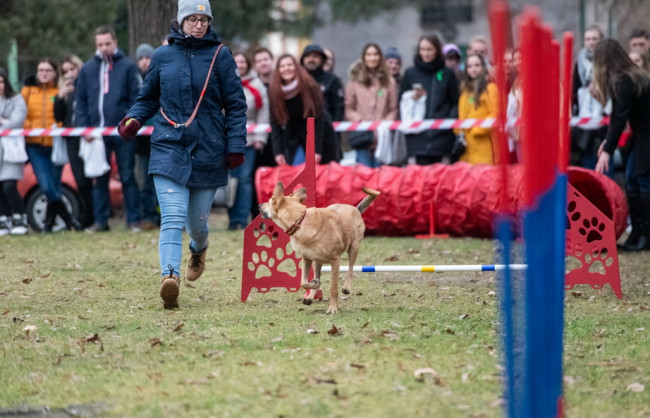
[458,83,499,164]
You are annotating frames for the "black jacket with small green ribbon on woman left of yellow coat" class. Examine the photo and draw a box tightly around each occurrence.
[399,55,460,157]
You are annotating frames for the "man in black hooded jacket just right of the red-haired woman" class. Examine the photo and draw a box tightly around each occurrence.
[300,44,345,125]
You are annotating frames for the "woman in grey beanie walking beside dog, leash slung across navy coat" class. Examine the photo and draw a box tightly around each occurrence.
[118,0,246,309]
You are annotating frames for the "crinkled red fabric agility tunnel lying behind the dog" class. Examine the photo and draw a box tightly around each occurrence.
[255,162,627,238]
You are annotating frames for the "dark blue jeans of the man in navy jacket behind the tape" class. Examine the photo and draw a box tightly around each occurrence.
[93,136,141,226]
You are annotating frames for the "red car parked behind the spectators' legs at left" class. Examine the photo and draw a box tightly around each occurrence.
[18,156,123,232]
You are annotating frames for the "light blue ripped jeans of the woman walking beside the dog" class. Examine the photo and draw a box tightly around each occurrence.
[153,175,216,277]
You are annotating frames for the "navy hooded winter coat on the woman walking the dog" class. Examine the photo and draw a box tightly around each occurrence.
[127,28,247,188]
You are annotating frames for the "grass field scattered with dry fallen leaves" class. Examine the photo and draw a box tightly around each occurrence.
[0,212,650,417]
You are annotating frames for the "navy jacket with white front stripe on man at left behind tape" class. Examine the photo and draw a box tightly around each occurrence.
[75,49,142,127]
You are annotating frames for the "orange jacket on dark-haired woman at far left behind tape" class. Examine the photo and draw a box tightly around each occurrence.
[22,81,59,147]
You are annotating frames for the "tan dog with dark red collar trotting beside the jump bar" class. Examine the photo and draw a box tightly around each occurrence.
[260,182,379,313]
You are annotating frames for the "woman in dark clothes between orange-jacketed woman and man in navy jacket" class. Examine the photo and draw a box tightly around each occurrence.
[54,55,93,228]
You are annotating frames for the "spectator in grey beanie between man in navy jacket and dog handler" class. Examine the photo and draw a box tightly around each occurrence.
[134,44,160,231]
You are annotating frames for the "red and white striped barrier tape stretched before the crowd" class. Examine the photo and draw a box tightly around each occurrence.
[0,117,609,136]
